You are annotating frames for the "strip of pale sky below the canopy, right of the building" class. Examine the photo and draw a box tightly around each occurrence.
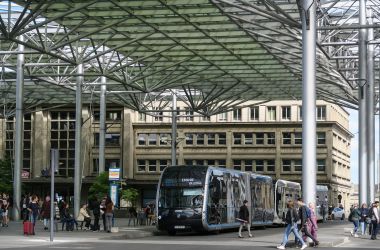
[348,109,379,184]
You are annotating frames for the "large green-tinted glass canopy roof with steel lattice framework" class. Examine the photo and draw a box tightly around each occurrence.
[0,0,379,115]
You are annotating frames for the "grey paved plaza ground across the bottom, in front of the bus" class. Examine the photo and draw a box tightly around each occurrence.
[0,219,380,250]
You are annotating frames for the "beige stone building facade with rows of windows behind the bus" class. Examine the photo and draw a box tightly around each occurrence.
[0,101,353,210]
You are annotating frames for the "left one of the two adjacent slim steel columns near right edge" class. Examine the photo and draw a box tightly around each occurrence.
[358,0,368,204]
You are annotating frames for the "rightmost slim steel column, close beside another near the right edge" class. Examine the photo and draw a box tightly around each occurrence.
[366,9,376,202]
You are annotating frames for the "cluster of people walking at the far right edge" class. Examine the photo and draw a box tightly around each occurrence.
[348,201,380,240]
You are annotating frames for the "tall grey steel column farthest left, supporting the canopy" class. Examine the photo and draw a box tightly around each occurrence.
[13,36,25,220]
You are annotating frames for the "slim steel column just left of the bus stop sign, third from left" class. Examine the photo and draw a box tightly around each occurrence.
[99,76,107,174]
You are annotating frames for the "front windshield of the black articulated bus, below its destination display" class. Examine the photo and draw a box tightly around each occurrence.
[158,187,203,208]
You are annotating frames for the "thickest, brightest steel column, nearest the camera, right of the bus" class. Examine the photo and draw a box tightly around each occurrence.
[302,0,317,206]
